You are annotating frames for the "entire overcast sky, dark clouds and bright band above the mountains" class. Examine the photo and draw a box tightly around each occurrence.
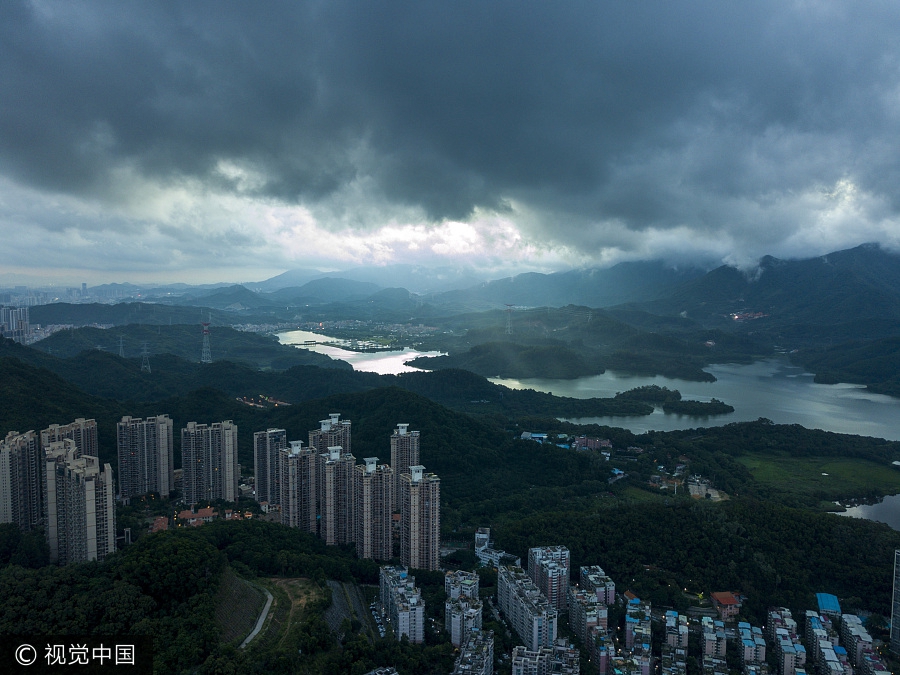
[0,0,900,283]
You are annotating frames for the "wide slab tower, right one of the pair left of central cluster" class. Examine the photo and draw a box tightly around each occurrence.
[181,420,240,506]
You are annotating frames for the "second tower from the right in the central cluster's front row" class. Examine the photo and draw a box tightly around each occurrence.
[354,457,394,560]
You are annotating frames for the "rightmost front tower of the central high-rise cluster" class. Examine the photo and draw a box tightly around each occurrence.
[399,466,441,570]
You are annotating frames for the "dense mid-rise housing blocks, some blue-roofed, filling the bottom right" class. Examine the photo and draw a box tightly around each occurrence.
[476,530,888,675]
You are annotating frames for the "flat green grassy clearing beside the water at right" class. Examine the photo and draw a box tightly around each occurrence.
[737,454,900,500]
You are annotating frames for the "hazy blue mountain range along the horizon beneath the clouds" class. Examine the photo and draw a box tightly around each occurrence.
[45,244,900,337]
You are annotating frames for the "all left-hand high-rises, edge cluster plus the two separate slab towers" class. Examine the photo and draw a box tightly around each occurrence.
[0,415,240,565]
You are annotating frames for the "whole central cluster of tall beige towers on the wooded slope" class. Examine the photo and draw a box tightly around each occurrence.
[253,413,441,570]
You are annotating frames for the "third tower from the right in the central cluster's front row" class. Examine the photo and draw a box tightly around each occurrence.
[316,446,356,545]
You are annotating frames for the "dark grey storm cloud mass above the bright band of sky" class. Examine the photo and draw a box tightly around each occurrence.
[0,0,900,256]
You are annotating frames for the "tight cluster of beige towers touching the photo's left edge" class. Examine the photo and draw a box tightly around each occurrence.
[0,419,116,565]
